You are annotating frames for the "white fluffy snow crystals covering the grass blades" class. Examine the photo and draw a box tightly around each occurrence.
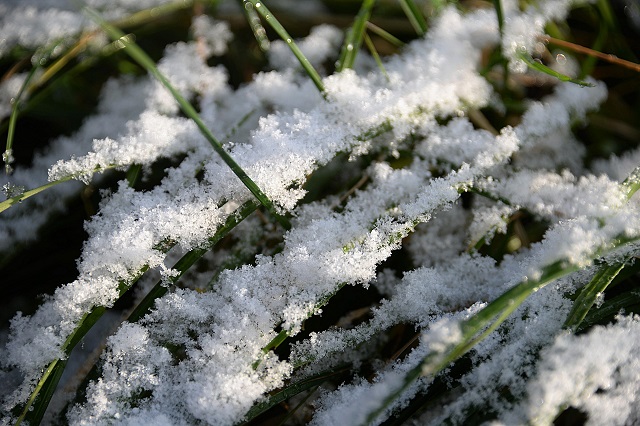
[0,0,640,425]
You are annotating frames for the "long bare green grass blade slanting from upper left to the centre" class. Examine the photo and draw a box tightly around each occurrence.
[84,7,291,229]
